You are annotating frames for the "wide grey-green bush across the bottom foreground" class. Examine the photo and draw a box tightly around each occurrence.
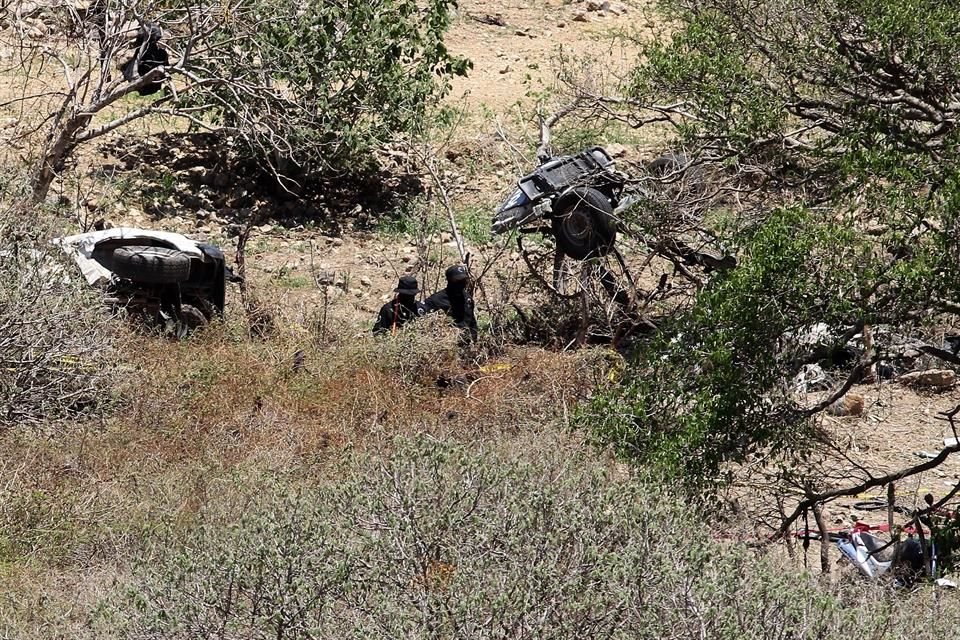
[116,437,952,640]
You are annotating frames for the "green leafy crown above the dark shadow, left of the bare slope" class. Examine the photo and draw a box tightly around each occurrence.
[177,0,470,171]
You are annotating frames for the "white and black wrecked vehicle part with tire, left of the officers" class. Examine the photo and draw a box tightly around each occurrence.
[54,228,238,337]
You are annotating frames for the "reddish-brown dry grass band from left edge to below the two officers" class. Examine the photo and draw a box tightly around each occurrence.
[0,308,600,628]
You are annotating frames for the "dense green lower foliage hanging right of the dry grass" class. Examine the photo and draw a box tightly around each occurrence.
[580,195,958,487]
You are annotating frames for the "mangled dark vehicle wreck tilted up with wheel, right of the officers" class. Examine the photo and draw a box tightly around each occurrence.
[491,147,627,260]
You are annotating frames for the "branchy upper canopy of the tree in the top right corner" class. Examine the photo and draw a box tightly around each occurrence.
[631,0,960,189]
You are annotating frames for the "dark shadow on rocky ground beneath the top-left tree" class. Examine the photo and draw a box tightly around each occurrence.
[94,132,423,235]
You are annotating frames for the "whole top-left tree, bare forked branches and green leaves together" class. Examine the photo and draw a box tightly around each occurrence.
[3,0,469,202]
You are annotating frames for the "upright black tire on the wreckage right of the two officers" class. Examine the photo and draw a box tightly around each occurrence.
[552,187,617,260]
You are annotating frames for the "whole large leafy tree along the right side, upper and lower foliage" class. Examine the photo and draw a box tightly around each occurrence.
[585,0,960,483]
